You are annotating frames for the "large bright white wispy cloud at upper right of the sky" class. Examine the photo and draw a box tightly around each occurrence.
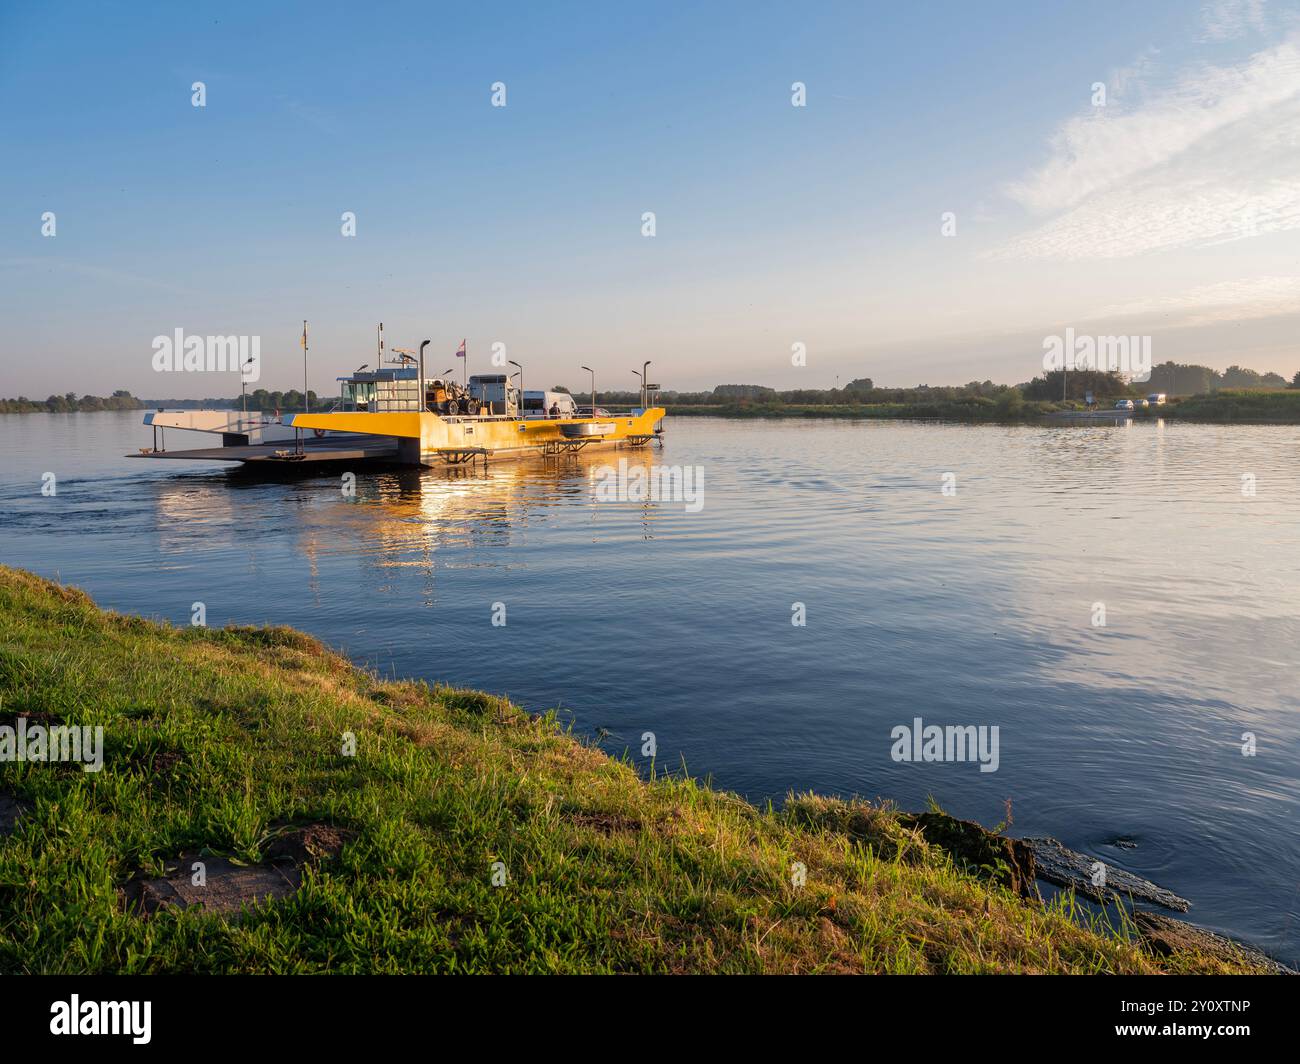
[991,36,1300,259]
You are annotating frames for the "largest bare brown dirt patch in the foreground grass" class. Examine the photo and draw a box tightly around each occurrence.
[122,823,354,916]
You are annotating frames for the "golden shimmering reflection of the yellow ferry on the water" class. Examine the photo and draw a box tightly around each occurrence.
[152,447,683,613]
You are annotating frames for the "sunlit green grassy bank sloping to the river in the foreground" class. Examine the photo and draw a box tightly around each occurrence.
[0,567,1263,973]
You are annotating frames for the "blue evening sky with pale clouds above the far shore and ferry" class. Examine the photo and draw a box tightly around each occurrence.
[0,0,1300,397]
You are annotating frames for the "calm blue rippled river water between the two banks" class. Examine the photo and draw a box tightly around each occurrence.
[0,414,1300,964]
